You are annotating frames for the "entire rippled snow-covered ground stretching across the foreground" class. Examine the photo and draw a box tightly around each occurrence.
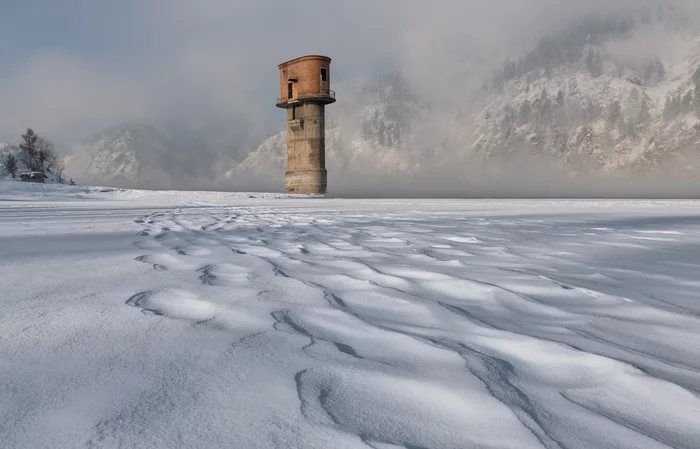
[0,182,700,449]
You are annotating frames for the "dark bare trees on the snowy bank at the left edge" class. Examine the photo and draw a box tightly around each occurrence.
[3,128,63,182]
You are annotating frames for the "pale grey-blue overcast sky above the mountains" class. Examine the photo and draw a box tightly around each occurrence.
[0,0,688,149]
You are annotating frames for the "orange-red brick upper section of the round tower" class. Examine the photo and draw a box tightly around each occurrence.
[277,55,335,109]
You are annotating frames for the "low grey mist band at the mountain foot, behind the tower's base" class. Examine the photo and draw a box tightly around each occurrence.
[228,151,700,199]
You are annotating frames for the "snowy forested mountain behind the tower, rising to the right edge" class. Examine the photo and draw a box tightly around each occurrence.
[234,4,700,194]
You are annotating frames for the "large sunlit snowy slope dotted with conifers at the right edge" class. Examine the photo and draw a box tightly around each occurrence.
[464,14,700,173]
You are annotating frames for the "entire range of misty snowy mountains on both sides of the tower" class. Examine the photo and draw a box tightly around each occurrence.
[60,2,700,195]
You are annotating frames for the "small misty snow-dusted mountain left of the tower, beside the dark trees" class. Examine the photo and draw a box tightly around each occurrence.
[64,123,224,188]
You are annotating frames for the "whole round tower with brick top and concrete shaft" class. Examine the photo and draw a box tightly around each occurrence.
[277,55,335,194]
